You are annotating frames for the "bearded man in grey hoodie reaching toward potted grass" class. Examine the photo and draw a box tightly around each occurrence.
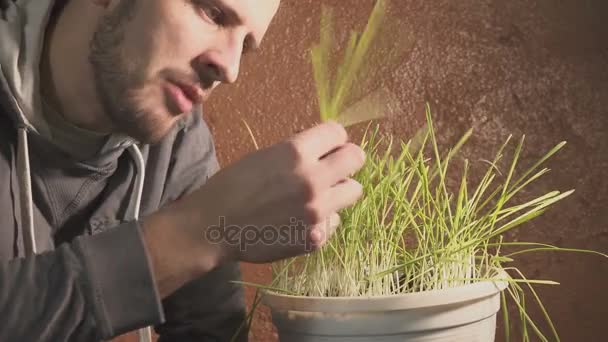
[0,0,364,342]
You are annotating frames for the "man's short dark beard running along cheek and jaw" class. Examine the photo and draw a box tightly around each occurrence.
[89,0,171,143]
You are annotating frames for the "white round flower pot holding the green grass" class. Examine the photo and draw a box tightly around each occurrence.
[263,273,508,342]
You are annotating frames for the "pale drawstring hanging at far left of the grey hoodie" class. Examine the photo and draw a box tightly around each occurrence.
[17,127,37,255]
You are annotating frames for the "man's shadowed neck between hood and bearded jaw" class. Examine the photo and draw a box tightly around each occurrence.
[40,1,112,133]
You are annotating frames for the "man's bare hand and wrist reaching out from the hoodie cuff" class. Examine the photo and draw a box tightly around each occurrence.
[144,122,365,292]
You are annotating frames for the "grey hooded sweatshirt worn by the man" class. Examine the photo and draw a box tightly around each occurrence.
[0,0,246,342]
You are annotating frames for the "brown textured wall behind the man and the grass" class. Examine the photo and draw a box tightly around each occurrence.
[116,0,608,342]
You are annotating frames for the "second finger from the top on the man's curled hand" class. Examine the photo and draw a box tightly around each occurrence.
[318,143,365,187]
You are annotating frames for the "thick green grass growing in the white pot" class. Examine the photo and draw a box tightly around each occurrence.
[264,106,608,341]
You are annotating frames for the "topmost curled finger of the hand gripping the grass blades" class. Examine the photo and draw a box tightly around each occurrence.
[291,121,348,159]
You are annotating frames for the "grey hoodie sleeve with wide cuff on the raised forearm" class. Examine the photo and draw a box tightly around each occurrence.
[0,222,163,342]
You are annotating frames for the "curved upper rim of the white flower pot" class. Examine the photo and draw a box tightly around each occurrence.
[262,269,510,313]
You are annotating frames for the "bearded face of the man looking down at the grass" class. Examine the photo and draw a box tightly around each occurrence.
[89,0,280,142]
